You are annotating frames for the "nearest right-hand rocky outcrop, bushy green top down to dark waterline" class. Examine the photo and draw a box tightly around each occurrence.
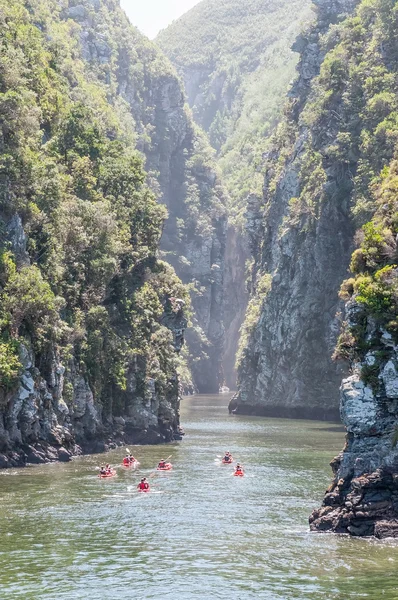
[310,161,398,538]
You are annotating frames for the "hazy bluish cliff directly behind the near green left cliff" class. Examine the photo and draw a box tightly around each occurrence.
[68,2,226,392]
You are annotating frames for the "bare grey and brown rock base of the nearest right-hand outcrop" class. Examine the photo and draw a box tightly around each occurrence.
[310,324,398,538]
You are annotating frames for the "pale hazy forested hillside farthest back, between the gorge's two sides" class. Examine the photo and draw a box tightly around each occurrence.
[156,0,313,386]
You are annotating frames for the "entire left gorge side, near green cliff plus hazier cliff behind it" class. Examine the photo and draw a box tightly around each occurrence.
[0,0,225,466]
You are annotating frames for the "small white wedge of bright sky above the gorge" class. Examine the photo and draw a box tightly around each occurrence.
[121,0,200,39]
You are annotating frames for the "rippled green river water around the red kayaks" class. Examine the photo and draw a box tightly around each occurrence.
[0,396,398,600]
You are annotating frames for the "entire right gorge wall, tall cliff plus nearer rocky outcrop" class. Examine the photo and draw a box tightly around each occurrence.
[231,0,398,538]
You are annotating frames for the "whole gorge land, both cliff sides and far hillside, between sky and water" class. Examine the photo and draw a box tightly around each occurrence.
[0,0,398,538]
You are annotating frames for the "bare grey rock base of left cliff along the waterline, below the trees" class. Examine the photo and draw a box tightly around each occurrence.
[0,336,185,468]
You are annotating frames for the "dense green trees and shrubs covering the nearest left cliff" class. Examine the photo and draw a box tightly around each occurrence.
[0,0,187,414]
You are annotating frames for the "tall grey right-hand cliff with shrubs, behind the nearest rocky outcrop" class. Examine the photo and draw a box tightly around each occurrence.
[231,0,395,418]
